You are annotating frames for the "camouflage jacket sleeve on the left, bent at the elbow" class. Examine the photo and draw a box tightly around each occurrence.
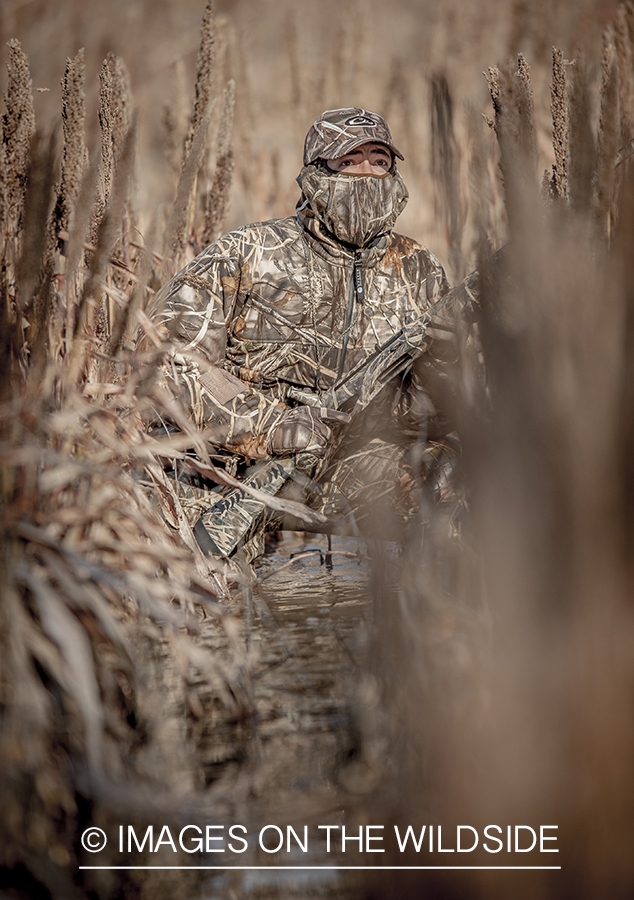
[153,232,286,458]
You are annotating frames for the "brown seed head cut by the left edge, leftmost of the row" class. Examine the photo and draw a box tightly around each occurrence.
[2,38,35,246]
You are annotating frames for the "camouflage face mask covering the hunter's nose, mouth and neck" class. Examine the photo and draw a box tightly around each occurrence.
[297,165,409,247]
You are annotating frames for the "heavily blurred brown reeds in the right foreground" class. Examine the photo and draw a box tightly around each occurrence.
[361,4,634,898]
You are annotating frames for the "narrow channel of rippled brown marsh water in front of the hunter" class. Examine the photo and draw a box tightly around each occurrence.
[195,532,380,900]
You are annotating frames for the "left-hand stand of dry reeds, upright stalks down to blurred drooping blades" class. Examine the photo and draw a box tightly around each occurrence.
[0,31,249,897]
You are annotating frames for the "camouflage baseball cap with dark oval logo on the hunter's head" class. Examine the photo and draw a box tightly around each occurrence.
[304,106,404,166]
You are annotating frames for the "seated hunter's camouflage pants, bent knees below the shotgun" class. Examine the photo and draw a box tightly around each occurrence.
[179,438,458,561]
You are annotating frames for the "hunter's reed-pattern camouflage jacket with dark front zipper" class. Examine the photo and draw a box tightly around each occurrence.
[154,209,448,458]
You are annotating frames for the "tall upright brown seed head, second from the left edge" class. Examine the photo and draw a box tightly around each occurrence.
[54,49,88,241]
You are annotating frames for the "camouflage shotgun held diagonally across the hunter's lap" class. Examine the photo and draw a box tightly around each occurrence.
[194,271,479,558]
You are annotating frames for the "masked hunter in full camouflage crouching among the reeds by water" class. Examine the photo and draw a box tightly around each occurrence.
[155,107,457,559]
